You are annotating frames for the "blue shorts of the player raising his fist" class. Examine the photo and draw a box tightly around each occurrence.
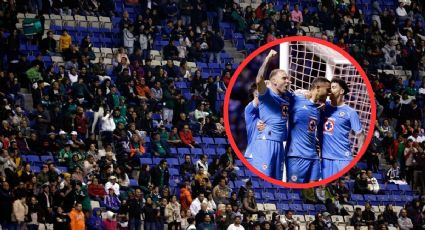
[245,140,284,180]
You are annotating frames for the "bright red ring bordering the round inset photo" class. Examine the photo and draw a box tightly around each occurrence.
[223,36,376,188]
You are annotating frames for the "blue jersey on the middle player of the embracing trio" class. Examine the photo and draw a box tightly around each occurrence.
[287,95,322,159]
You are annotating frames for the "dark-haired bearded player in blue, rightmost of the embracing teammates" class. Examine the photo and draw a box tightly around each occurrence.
[322,78,364,179]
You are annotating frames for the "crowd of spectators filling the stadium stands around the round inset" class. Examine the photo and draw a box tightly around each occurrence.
[0,0,425,230]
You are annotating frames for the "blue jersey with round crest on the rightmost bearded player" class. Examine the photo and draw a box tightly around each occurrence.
[322,103,362,160]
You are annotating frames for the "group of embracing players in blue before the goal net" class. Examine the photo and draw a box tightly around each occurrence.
[245,50,364,183]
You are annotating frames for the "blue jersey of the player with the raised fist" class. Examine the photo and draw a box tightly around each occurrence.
[256,88,289,142]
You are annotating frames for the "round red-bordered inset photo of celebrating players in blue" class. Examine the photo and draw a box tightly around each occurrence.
[224,36,376,188]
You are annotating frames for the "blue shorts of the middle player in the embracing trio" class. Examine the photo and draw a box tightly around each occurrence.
[286,157,321,183]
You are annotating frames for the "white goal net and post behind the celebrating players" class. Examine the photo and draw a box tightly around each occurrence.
[279,42,371,154]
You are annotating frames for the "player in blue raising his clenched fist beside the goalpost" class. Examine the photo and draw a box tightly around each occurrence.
[248,50,291,180]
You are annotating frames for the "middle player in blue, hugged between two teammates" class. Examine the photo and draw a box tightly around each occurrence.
[284,77,331,183]
